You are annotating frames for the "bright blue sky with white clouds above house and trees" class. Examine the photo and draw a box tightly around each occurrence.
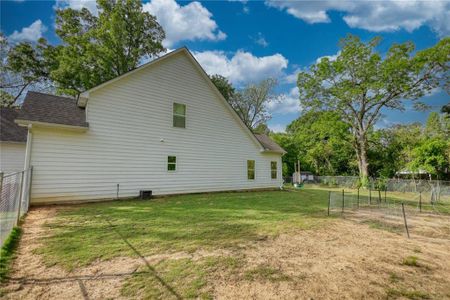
[1,0,450,131]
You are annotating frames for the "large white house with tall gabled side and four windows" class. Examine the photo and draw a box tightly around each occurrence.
[16,48,285,204]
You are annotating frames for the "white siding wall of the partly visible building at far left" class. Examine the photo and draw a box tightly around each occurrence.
[0,142,25,174]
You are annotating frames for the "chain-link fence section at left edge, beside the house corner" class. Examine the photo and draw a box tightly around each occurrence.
[0,168,33,246]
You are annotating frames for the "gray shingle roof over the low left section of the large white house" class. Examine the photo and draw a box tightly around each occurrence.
[17,92,88,127]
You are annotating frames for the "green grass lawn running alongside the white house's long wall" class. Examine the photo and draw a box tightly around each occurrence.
[37,189,329,270]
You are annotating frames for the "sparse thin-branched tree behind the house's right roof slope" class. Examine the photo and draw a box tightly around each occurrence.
[228,78,278,128]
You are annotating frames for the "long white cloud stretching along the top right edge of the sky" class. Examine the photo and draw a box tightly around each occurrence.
[266,0,450,36]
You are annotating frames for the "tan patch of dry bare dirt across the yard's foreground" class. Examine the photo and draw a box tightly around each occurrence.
[3,207,450,299]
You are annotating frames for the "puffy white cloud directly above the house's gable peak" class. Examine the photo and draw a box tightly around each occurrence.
[143,0,227,47]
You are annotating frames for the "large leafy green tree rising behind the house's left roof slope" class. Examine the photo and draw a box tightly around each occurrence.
[51,0,165,95]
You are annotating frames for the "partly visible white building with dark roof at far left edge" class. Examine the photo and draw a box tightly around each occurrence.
[0,108,27,174]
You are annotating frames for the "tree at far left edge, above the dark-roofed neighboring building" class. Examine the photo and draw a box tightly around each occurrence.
[0,33,55,107]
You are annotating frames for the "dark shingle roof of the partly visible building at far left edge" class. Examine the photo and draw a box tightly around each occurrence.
[0,107,28,143]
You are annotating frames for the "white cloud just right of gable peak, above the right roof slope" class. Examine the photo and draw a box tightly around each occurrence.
[193,50,288,85]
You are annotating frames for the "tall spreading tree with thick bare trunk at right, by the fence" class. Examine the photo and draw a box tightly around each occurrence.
[297,35,450,180]
